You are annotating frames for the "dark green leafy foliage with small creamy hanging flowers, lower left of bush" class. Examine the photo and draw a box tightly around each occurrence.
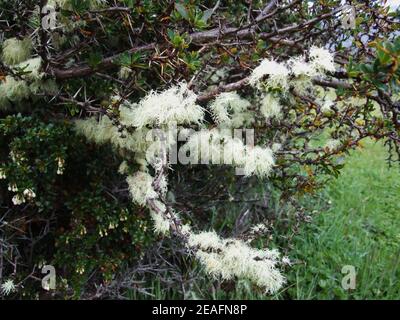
[0,115,153,297]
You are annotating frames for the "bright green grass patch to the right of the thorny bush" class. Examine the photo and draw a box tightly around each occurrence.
[285,143,400,299]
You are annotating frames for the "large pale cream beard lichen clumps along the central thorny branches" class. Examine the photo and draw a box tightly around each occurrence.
[71,47,333,293]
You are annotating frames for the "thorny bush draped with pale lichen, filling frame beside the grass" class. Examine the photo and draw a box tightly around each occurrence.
[0,0,400,298]
